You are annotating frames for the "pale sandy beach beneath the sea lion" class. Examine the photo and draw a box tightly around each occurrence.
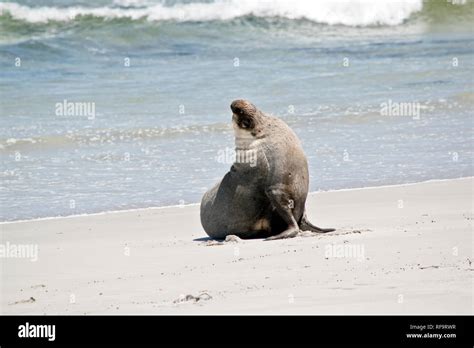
[0,178,474,314]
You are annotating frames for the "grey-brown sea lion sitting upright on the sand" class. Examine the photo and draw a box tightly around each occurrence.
[201,100,334,240]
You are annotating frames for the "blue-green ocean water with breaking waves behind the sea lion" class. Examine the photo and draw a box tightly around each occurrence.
[0,0,474,221]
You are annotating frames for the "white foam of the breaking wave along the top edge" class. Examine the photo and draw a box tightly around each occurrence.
[0,0,423,26]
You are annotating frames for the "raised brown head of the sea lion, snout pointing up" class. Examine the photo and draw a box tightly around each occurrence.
[230,99,263,136]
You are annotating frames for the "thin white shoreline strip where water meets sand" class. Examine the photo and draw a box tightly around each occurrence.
[0,176,474,226]
